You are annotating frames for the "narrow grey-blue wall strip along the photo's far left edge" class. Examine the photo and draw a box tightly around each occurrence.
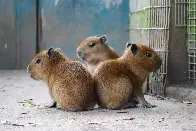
[0,0,16,69]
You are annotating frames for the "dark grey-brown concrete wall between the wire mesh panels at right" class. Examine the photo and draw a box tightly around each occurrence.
[168,0,188,84]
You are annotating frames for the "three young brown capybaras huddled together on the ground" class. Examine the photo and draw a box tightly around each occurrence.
[27,35,162,111]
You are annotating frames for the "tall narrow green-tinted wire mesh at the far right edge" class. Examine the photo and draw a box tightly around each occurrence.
[187,0,196,81]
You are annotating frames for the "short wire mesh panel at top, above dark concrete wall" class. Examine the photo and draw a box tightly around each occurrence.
[175,0,188,26]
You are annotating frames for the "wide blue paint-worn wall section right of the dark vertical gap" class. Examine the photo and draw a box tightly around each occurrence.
[39,0,129,60]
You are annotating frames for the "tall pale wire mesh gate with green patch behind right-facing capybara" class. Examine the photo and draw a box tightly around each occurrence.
[130,0,170,95]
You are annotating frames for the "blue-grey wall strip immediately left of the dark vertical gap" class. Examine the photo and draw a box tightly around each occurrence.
[16,0,36,69]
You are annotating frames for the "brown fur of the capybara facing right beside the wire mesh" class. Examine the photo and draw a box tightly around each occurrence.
[94,44,161,109]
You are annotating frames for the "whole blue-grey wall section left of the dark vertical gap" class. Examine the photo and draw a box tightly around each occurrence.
[0,0,36,69]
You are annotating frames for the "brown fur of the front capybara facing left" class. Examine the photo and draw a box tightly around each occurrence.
[28,49,96,111]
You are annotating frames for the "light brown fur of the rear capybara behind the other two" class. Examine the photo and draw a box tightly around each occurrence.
[77,36,119,74]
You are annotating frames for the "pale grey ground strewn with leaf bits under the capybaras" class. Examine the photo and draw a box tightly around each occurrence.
[0,71,196,131]
